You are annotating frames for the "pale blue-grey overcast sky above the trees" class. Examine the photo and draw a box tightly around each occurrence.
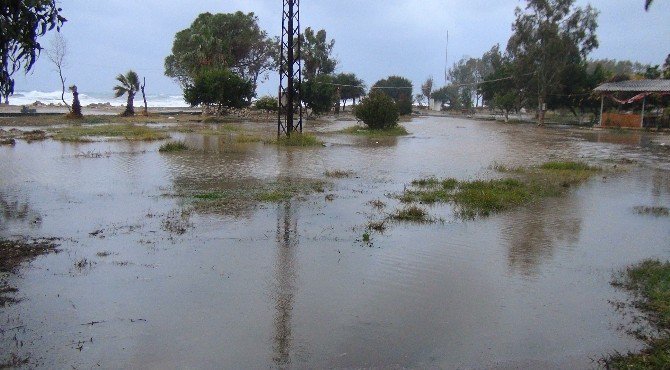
[16,0,670,95]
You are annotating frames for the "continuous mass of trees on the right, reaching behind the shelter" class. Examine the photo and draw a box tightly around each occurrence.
[422,0,670,123]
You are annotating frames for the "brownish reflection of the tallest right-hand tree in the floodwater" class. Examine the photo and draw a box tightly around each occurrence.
[501,195,582,276]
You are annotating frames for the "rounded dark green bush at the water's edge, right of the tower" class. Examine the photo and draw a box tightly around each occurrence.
[354,91,400,129]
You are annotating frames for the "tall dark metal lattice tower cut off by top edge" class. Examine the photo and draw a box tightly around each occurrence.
[277,0,303,136]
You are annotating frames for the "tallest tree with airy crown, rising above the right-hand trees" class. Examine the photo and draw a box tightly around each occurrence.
[507,0,598,124]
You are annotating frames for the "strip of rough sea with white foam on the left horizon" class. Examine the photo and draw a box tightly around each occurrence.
[9,91,189,108]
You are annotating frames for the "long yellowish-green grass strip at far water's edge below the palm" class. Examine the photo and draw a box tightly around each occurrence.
[54,124,170,142]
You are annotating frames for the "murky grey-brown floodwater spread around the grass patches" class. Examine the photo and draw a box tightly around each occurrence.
[0,118,670,369]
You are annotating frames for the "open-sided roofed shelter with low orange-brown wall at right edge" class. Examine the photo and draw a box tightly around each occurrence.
[593,80,670,128]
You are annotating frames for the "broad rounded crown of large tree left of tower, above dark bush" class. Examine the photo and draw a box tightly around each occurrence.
[165,12,278,89]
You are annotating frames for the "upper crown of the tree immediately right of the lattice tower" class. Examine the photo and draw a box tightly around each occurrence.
[300,27,337,80]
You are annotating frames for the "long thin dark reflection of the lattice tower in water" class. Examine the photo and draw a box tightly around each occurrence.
[273,200,298,366]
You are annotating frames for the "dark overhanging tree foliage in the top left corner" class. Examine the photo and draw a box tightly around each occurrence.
[0,0,66,104]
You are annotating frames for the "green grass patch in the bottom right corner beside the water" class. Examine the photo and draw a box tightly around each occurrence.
[603,260,670,369]
